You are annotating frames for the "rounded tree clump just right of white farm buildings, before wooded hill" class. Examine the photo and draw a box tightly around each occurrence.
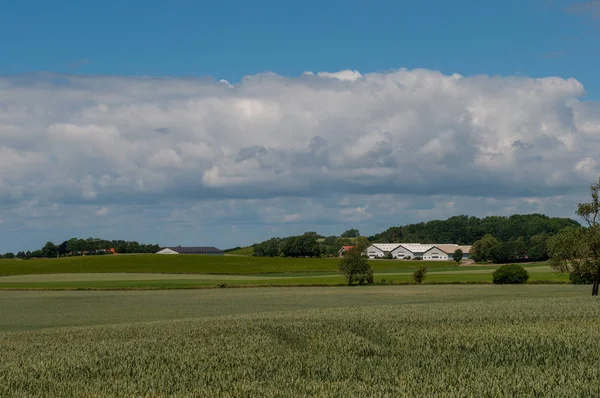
[471,234,550,264]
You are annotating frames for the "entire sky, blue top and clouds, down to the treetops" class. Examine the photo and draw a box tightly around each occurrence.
[0,0,600,252]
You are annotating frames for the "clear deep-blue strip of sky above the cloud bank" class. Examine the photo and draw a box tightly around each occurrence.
[0,0,600,97]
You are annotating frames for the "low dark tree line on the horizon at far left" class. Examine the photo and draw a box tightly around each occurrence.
[2,238,160,260]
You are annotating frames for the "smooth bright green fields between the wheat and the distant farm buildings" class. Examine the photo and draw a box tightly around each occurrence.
[0,255,569,290]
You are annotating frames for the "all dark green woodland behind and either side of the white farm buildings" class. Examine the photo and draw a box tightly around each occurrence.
[253,214,581,263]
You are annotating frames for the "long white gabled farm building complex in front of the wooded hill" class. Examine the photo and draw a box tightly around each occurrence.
[363,243,471,261]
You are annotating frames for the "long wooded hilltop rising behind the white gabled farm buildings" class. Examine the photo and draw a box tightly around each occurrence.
[369,214,580,245]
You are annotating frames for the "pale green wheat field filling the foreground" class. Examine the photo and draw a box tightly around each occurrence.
[0,285,600,397]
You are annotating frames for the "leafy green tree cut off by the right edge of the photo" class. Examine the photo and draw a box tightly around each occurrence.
[548,179,600,296]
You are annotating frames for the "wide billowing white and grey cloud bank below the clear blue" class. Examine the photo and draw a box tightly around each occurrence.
[0,69,600,249]
